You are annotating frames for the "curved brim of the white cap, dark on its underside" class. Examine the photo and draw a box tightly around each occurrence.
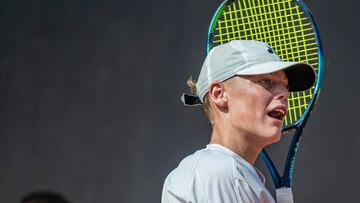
[236,61,316,92]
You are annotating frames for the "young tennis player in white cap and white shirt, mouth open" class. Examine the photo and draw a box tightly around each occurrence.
[161,40,315,203]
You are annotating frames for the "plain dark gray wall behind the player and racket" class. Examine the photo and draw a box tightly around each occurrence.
[0,0,360,203]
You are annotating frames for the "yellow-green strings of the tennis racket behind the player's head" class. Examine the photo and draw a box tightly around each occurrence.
[211,0,318,127]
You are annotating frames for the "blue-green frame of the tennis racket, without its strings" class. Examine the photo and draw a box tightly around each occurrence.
[206,0,325,189]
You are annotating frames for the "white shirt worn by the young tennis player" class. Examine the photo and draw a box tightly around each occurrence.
[161,144,275,203]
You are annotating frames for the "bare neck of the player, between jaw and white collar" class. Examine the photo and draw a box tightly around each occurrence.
[210,122,262,165]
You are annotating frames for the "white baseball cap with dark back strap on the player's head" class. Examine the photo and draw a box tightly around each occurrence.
[182,40,315,106]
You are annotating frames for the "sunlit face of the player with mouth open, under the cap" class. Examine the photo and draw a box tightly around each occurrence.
[225,71,289,147]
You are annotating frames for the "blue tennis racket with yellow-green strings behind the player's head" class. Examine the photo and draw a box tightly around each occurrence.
[207,0,324,202]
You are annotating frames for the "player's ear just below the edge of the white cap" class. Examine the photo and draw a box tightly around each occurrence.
[209,81,228,108]
